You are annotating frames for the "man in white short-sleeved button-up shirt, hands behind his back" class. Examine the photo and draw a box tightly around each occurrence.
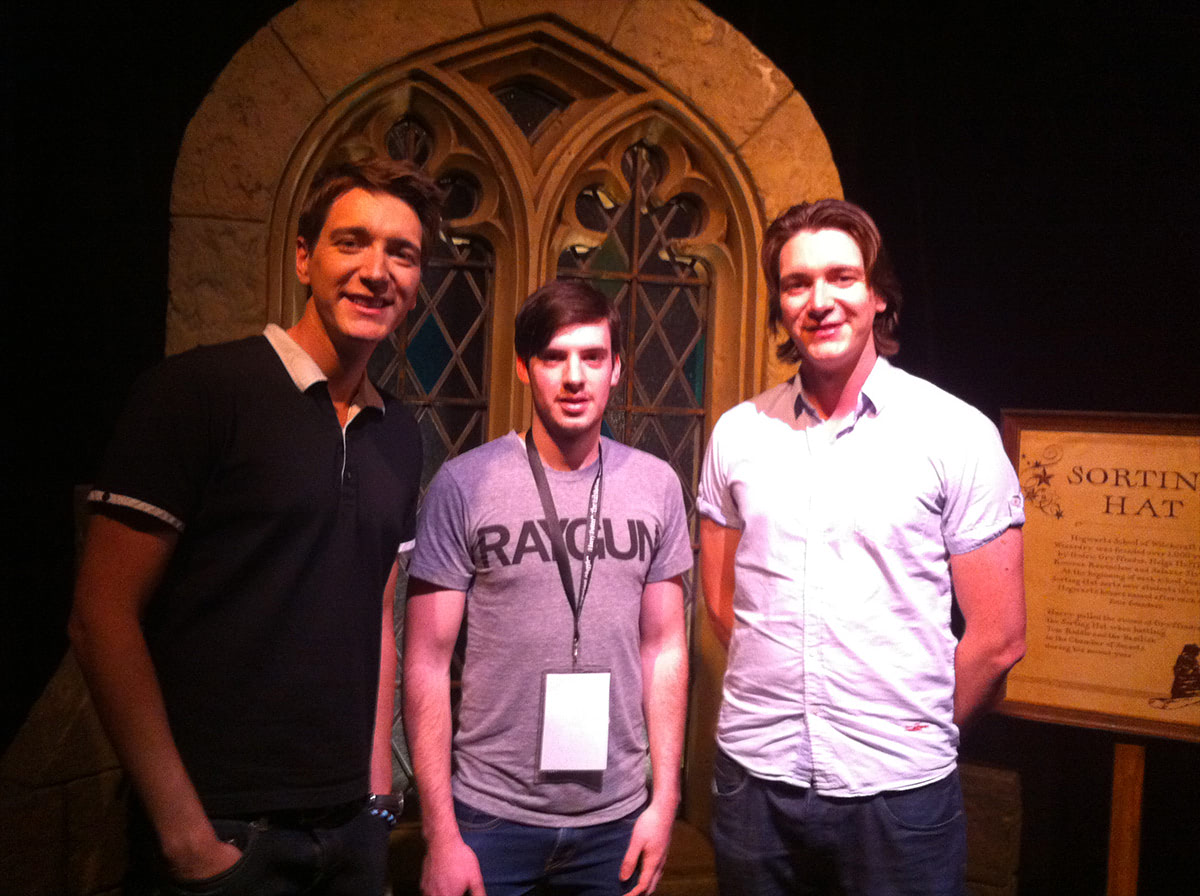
[698,199,1025,896]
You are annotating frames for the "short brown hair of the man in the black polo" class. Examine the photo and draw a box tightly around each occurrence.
[296,156,443,259]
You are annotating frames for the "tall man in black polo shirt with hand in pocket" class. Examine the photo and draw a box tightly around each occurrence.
[71,160,439,896]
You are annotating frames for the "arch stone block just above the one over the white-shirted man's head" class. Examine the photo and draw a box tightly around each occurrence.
[612,0,792,145]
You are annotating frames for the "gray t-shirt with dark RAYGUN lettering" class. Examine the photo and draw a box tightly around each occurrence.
[409,433,692,826]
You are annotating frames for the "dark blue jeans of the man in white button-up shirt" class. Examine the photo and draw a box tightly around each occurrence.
[713,752,967,896]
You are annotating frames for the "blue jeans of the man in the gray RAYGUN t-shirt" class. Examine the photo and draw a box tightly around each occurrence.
[455,800,641,896]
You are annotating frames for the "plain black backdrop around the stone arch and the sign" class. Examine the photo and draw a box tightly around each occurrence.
[0,0,1200,896]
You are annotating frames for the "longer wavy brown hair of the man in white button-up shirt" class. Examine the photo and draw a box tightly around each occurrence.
[762,199,904,363]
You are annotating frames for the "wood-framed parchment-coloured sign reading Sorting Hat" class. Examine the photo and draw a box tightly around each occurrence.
[1001,410,1200,742]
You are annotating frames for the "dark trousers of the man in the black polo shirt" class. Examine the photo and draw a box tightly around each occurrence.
[126,806,389,896]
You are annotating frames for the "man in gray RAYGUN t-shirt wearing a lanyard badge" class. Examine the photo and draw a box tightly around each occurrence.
[404,281,692,896]
